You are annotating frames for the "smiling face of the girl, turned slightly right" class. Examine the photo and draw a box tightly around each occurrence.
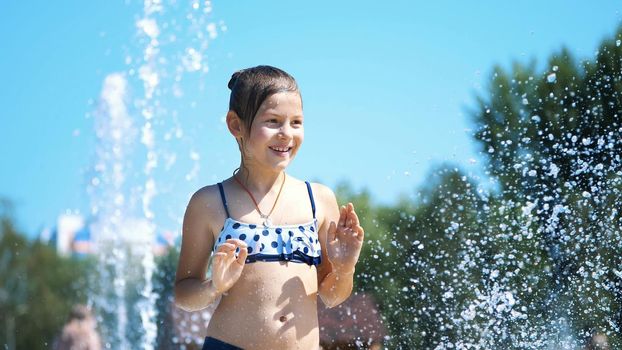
[243,92,304,170]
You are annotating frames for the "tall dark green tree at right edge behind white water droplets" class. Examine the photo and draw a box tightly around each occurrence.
[473,27,622,346]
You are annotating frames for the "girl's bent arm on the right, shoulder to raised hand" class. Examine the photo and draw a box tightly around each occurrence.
[318,186,364,308]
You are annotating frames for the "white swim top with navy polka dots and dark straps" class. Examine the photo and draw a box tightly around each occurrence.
[212,181,322,265]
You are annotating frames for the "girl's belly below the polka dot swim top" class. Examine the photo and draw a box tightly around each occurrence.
[207,262,319,350]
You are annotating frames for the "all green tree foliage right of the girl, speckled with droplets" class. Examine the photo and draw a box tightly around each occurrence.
[340,25,622,348]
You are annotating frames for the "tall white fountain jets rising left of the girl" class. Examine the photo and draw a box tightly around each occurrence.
[87,0,226,349]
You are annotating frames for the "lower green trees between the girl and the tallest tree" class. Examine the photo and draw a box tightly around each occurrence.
[337,165,488,348]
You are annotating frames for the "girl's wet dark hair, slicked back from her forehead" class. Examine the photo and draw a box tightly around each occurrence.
[228,66,302,132]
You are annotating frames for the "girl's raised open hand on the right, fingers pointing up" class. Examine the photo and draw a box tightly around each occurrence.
[326,203,365,273]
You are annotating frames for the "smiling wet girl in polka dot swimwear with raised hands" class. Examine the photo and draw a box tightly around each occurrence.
[175,66,364,349]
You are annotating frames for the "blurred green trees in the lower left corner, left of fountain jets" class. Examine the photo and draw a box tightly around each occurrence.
[0,201,89,349]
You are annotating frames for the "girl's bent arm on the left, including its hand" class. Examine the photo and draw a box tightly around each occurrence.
[175,186,248,311]
